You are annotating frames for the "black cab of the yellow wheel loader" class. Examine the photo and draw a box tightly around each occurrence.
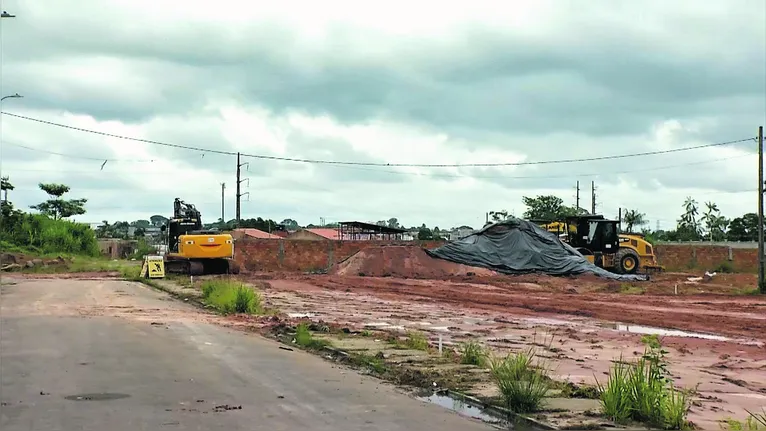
[566,215,620,254]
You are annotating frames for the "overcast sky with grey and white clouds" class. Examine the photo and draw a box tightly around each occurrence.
[0,0,766,228]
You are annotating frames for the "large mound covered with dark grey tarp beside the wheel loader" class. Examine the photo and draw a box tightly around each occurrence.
[426,218,647,280]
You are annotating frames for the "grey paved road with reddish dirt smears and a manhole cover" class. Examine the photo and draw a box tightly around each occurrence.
[0,277,489,431]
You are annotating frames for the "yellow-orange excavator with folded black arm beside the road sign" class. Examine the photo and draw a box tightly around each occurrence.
[161,198,239,275]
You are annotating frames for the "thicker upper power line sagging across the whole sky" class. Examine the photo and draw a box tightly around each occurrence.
[2,112,754,168]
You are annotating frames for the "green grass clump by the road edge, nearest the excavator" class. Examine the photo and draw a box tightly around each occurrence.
[202,280,263,314]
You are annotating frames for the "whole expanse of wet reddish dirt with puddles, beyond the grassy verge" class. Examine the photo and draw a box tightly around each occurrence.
[243,274,766,429]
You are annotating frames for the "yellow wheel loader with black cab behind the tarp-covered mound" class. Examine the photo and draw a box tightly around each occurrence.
[535,215,664,274]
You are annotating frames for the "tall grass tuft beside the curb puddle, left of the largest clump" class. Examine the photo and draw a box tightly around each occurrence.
[490,348,551,413]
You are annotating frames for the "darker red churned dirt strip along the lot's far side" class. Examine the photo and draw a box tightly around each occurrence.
[256,274,766,337]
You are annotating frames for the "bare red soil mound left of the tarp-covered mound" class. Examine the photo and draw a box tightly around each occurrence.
[334,246,497,278]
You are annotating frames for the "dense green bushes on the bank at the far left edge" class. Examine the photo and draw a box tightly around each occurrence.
[0,211,100,256]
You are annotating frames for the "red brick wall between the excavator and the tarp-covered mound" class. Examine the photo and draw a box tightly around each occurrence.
[235,238,443,272]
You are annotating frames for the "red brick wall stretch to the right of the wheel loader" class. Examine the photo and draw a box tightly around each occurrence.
[654,244,758,272]
